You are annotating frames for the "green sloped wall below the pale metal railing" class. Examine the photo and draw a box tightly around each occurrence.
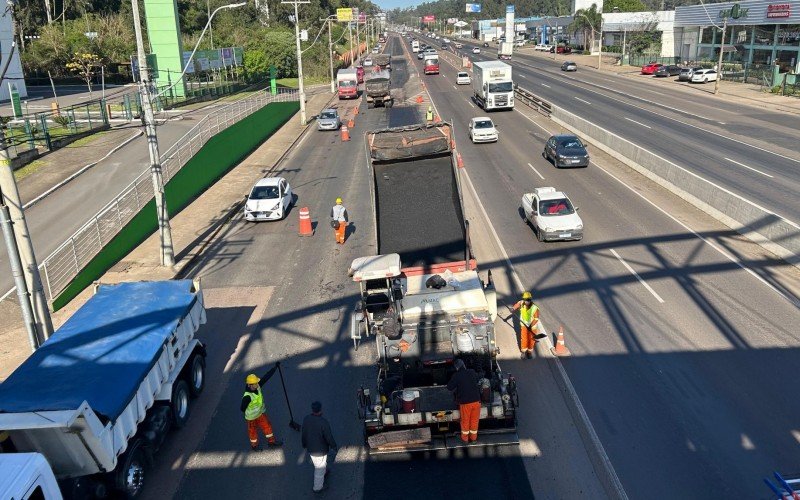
[53,102,300,311]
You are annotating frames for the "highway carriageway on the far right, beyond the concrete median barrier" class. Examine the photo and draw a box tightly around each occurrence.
[454,41,800,223]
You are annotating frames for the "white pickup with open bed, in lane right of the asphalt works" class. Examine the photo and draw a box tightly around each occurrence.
[522,187,583,241]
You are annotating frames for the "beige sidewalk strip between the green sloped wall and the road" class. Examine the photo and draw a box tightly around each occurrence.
[0,94,331,381]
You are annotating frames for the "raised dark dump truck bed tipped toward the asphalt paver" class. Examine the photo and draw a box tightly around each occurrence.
[370,125,466,267]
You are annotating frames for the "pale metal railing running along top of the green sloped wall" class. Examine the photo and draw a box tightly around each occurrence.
[41,89,298,301]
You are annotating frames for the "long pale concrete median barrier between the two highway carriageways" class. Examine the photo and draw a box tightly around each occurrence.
[550,107,800,267]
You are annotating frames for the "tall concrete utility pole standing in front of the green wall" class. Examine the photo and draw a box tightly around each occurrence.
[131,0,175,267]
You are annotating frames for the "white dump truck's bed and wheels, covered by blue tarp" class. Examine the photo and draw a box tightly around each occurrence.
[0,280,206,498]
